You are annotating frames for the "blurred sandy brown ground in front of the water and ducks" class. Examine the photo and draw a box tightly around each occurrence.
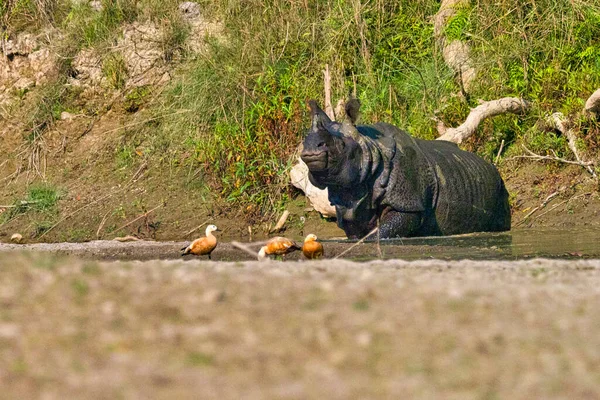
[0,252,600,399]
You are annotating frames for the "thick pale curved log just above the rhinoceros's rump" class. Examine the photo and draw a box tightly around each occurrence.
[438,97,530,143]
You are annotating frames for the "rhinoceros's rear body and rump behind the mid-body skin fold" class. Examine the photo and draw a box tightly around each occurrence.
[416,140,510,235]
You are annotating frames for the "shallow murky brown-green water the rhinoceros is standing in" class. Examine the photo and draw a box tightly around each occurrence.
[324,228,600,260]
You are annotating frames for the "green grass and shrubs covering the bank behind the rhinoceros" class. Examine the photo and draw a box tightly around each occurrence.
[1,0,600,216]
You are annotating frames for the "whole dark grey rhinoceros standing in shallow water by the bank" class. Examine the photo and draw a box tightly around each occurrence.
[300,99,510,238]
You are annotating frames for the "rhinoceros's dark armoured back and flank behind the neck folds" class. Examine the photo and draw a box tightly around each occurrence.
[375,123,510,235]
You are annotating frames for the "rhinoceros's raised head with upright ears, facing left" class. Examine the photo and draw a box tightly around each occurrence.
[300,100,362,188]
